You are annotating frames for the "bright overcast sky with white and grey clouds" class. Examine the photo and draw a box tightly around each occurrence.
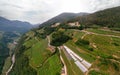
[0,0,120,24]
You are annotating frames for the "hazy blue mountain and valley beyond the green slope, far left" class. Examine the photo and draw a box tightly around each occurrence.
[0,17,33,74]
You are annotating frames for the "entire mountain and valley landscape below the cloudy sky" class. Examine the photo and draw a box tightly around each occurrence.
[0,7,120,75]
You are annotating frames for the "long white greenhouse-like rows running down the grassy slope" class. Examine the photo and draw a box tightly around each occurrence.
[63,45,92,73]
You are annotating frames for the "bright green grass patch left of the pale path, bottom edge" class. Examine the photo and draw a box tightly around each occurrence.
[38,53,62,75]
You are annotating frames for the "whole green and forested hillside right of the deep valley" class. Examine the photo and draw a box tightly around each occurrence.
[9,7,120,75]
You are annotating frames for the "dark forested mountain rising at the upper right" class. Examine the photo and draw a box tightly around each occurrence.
[73,6,120,28]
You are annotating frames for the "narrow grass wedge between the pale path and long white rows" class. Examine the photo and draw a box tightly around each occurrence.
[61,51,84,75]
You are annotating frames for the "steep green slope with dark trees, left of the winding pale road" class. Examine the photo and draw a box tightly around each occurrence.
[10,29,62,75]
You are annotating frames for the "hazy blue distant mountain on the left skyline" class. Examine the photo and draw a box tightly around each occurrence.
[0,17,33,33]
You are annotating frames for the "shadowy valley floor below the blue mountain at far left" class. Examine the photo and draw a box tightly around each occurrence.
[0,32,20,75]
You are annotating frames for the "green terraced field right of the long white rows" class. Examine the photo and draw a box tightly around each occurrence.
[65,29,120,75]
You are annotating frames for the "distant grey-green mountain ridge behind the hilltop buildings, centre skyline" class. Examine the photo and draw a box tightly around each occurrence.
[40,13,88,26]
